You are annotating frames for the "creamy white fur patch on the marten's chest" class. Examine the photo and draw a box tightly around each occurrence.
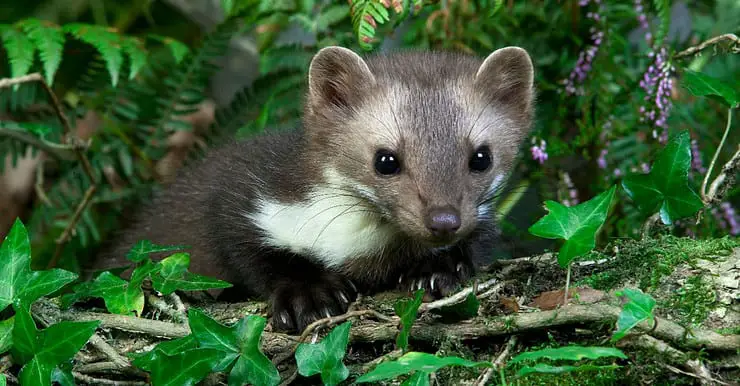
[245,182,396,267]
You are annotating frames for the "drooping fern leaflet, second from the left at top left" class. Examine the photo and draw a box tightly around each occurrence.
[19,18,64,86]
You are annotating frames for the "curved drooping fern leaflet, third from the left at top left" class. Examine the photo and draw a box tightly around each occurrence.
[64,23,123,87]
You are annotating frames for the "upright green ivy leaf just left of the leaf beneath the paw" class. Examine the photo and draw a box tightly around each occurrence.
[229,315,280,386]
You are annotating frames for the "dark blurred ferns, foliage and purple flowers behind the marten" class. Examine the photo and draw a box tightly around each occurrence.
[0,0,740,271]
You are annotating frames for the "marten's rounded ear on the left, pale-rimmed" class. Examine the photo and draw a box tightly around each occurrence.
[308,46,375,111]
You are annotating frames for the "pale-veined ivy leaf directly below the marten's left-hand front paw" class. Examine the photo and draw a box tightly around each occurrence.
[295,322,352,385]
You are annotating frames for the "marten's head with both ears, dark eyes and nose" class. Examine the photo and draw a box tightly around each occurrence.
[305,47,534,250]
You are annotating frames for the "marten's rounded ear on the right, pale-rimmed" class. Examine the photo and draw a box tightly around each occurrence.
[475,47,534,114]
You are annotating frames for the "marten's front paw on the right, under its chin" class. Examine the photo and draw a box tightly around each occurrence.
[398,262,474,301]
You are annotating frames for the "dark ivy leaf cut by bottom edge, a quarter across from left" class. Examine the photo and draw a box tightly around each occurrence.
[150,348,223,386]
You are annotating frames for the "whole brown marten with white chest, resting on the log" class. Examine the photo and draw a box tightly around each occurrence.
[96,47,533,330]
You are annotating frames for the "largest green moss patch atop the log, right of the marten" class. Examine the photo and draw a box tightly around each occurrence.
[576,235,740,291]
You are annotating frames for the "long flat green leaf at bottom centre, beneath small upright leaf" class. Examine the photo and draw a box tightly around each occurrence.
[356,351,492,383]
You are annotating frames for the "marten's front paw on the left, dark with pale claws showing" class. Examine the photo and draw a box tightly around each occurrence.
[271,274,357,331]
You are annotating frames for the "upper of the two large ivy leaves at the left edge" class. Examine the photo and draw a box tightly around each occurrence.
[0,219,77,310]
